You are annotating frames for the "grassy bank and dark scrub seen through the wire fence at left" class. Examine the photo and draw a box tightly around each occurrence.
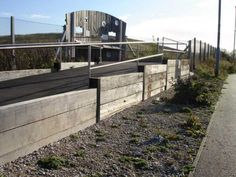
[0,33,61,71]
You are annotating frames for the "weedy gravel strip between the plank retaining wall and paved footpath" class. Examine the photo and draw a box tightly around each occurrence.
[0,90,212,177]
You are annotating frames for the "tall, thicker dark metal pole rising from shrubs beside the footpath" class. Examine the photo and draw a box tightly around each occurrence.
[215,0,221,77]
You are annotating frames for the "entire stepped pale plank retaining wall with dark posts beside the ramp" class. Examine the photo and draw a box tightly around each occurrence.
[0,60,189,165]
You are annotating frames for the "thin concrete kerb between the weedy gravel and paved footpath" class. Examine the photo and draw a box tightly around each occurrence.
[188,101,219,177]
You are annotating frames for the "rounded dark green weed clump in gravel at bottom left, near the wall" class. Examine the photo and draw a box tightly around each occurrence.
[37,156,67,170]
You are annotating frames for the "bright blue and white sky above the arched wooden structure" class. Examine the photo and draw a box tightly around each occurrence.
[0,0,236,51]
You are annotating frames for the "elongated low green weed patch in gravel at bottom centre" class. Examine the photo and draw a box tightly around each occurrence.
[119,156,148,169]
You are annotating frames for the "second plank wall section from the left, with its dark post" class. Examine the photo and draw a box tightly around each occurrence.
[90,73,143,121]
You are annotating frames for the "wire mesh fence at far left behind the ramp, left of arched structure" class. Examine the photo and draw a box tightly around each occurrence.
[0,17,63,71]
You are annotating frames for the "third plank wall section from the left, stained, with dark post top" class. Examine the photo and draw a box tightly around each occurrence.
[139,65,167,100]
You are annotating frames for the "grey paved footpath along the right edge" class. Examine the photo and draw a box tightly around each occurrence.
[194,75,236,177]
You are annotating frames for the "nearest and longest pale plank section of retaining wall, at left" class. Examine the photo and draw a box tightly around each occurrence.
[0,89,97,164]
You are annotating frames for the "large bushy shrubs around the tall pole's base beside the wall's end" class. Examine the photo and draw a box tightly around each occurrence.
[172,59,236,106]
